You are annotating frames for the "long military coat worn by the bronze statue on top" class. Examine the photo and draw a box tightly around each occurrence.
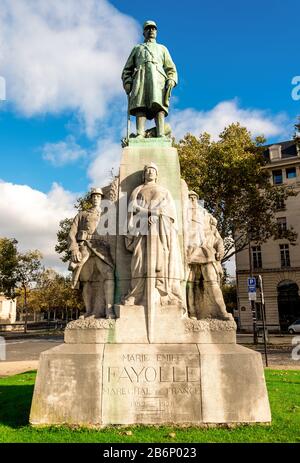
[122,42,178,119]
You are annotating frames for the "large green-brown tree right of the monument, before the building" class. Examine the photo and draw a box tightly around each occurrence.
[176,123,297,262]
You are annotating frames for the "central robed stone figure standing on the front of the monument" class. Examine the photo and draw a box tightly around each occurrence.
[125,163,182,305]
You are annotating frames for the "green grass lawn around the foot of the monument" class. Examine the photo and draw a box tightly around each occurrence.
[0,370,300,443]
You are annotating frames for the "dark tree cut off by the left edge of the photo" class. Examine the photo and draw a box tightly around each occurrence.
[0,238,18,299]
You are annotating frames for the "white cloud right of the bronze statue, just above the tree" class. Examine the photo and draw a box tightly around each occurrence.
[170,100,286,140]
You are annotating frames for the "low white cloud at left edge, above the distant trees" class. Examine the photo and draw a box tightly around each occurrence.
[0,180,77,271]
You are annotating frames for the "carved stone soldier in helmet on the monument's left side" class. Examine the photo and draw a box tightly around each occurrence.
[69,188,114,318]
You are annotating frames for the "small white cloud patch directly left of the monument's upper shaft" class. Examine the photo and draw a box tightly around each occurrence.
[88,140,121,187]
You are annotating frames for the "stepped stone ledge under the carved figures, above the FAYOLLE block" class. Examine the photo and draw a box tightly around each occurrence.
[65,305,236,344]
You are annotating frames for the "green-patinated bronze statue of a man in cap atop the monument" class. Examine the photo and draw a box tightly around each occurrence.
[122,21,178,138]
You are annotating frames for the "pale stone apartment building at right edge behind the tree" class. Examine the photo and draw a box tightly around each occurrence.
[235,141,300,332]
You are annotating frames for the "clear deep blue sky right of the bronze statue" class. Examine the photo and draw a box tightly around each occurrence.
[112,0,300,117]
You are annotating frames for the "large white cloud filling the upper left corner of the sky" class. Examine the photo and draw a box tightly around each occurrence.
[0,0,140,135]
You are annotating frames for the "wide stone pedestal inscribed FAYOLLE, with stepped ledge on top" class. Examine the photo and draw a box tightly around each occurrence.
[30,306,271,426]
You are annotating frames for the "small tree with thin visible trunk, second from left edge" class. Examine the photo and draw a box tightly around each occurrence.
[16,250,42,333]
